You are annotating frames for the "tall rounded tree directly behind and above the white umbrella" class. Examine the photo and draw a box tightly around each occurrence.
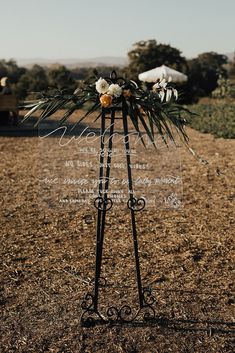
[126,40,186,80]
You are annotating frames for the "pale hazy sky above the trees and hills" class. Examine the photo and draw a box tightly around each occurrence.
[0,0,235,60]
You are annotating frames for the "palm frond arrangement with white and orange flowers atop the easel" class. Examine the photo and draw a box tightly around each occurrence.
[23,71,192,145]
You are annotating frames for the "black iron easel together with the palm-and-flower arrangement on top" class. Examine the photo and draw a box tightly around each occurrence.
[23,71,199,325]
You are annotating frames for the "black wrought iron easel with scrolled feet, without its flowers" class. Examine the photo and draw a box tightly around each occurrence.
[81,99,156,326]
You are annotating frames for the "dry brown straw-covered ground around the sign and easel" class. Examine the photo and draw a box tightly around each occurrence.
[0,113,235,353]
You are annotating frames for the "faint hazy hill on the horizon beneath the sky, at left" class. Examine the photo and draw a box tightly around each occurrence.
[17,56,128,69]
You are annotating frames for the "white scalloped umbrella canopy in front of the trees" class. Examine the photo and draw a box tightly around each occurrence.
[138,65,188,82]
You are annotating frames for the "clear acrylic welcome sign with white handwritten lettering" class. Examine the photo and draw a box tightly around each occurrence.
[38,111,182,209]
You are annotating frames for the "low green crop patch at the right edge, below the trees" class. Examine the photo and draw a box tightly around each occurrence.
[190,104,235,138]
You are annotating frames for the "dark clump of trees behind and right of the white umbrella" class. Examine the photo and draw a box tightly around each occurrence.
[125,40,228,103]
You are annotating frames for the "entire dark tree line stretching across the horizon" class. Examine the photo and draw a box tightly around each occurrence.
[0,40,235,103]
